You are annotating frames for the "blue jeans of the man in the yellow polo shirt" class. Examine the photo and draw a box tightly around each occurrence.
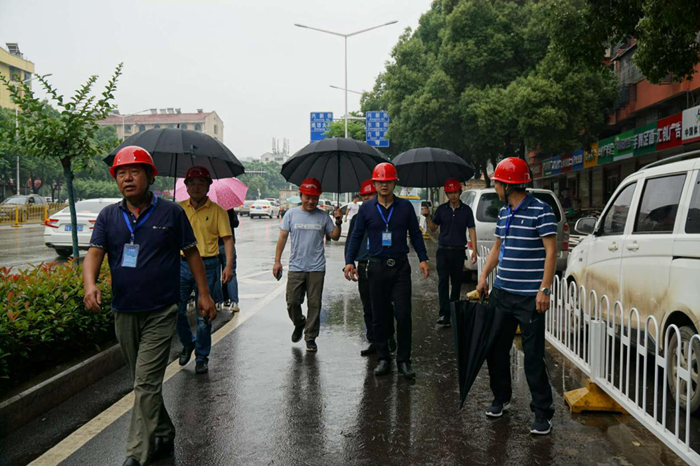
[176,257,221,362]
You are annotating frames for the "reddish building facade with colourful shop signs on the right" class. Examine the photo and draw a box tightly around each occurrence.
[529,41,700,211]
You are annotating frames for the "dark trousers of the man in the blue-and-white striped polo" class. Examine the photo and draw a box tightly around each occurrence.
[487,288,554,419]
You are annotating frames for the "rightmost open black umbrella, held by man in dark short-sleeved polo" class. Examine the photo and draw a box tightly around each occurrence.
[393,147,474,188]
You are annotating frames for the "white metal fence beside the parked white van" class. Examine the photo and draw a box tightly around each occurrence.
[478,247,700,465]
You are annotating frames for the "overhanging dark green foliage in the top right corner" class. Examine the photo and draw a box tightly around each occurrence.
[544,0,700,84]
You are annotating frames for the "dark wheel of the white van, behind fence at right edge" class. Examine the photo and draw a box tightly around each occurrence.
[666,326,700,413]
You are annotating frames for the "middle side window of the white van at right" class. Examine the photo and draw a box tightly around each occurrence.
[634,174,685,233]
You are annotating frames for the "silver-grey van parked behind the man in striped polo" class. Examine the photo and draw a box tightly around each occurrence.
[460,188,569,272]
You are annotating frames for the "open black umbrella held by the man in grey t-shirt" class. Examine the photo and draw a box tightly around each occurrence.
[282,138,388,193]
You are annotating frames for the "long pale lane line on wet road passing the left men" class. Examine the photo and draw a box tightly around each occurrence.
[30,280,287,466]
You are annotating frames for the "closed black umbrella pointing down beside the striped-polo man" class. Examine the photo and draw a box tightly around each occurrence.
[450,301,498,409]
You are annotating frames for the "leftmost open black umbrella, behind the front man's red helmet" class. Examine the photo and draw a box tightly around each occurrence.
[104,128,245,179]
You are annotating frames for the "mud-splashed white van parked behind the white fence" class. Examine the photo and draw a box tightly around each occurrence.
[564,151,700,412]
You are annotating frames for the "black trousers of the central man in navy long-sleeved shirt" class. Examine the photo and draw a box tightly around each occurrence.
[367,256,413,362]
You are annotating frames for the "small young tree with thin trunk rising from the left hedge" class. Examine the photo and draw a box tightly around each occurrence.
[0,63,122,258]
